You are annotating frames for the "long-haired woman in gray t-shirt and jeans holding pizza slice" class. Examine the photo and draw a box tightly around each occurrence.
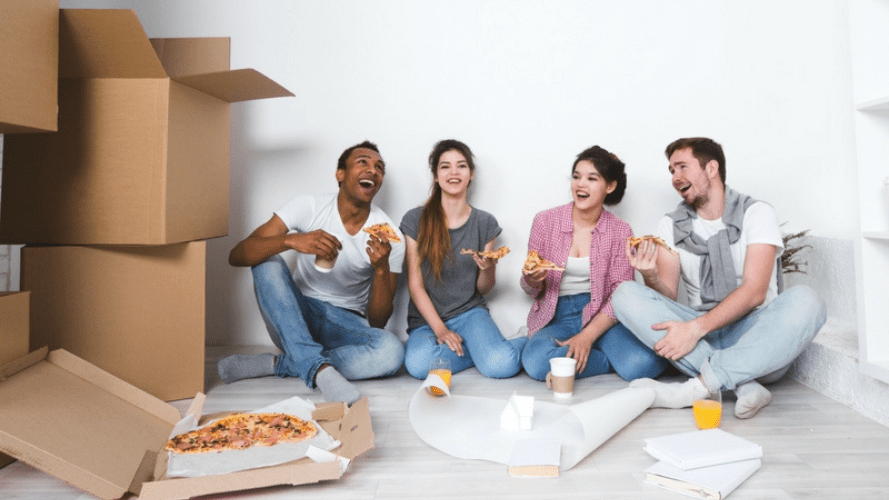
[400,139,528,379]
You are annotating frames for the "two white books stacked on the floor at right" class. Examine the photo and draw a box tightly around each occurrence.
[645,429,762,500]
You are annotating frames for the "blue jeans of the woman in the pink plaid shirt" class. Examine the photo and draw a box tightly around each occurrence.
[522,294,669,380]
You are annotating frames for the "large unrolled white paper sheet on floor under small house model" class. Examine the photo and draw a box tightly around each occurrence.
[409,376,654,471]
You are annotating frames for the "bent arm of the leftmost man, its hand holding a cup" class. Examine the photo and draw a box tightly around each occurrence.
[228,215,342,267]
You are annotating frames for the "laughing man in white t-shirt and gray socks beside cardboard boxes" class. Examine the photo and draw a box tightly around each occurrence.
[217,141,404,404]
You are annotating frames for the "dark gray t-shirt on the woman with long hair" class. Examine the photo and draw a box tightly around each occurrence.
[399,207,502,331]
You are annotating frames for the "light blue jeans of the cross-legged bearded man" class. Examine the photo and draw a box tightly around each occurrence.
[611,281,827,392]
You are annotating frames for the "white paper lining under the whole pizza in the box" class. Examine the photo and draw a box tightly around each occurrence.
[167,397,340,477]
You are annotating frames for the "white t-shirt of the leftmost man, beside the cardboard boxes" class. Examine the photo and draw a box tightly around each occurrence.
[275,193,404,315]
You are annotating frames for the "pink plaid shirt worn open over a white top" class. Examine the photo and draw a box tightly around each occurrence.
[519,202,634,335]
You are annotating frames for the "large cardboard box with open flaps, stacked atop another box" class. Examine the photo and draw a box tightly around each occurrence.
[0,9,293,245]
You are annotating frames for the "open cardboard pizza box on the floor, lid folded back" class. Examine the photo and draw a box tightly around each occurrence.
[0,348,374,500]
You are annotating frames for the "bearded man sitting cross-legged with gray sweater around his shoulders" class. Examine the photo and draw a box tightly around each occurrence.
[611,137,826,418]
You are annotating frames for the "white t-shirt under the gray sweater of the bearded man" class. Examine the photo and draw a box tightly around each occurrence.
[657,201,784,307]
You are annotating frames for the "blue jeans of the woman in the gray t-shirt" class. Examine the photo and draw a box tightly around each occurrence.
[404,307,528,379]
